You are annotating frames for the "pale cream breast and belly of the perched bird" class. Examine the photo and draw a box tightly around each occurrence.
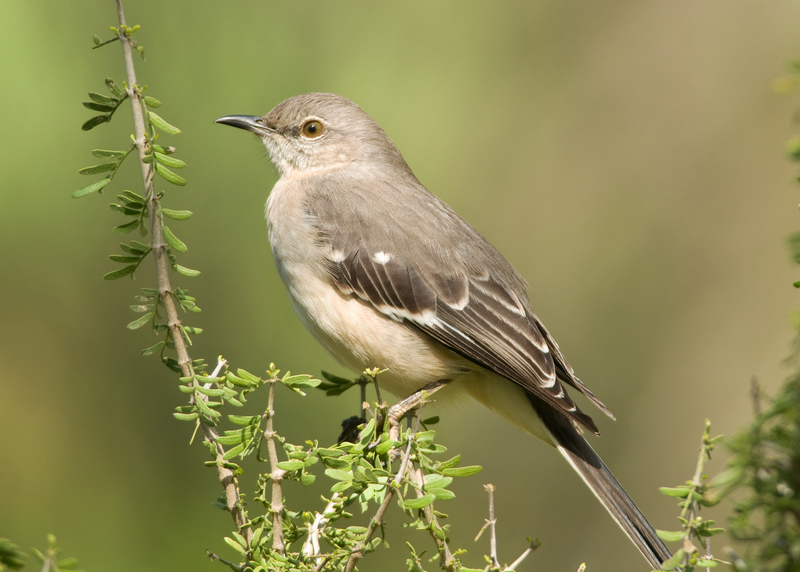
[267,179,469,397]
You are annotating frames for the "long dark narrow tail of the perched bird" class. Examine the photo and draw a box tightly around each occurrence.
[532,400,671,570]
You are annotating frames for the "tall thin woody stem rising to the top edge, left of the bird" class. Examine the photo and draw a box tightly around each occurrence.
[116,0,253,543]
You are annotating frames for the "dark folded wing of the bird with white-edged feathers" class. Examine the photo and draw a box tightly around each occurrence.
[329,243,597,433]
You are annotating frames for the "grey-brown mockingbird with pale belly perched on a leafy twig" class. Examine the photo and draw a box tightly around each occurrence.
[217,93,670,569]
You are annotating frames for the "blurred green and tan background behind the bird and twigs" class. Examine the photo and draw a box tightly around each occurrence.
[0,0,800,572]
